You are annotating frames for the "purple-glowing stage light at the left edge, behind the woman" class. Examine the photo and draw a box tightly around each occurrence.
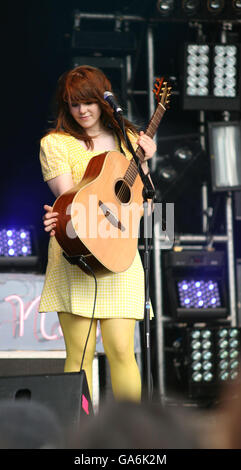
[0,227,38,267]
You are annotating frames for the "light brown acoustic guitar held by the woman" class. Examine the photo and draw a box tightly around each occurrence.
[53,78,171,277]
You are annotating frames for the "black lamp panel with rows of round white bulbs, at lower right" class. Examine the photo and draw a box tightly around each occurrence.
[164,323,241,404]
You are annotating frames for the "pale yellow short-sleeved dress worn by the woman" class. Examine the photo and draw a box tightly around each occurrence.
[39,133,152,320]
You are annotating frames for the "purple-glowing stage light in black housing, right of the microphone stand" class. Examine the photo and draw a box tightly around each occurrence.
[163,250,228,322]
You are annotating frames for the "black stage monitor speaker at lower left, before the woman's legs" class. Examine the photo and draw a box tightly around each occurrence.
[0,371,93,428]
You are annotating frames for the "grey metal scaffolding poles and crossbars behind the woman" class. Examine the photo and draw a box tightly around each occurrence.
[69,11,237,401]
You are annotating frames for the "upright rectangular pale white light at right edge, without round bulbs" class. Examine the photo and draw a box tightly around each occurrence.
[208,121,241,191]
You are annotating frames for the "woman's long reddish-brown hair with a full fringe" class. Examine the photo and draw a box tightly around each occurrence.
[48,65,137,149]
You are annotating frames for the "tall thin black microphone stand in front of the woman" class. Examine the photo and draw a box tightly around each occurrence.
[114,111,155,401]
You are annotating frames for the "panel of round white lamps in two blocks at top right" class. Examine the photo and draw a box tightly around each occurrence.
[183,43,240,111]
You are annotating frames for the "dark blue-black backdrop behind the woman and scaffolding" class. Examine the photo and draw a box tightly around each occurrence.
[0,0,238,269]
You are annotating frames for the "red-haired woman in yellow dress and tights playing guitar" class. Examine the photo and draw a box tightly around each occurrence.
[39,66,156,401]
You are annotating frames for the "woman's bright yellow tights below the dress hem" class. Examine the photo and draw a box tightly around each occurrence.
[58,312,141,402]
